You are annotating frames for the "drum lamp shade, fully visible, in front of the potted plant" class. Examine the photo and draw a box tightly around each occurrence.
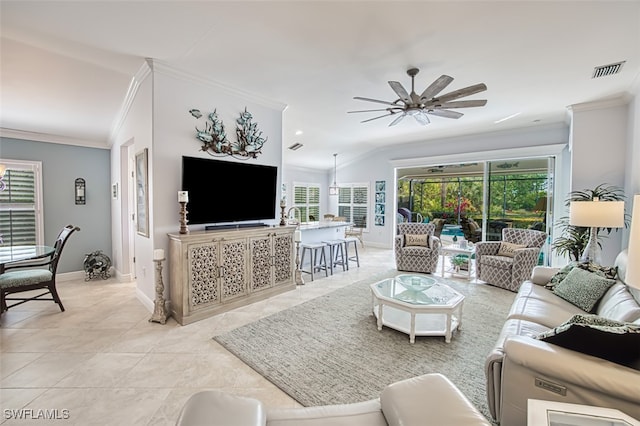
[569,201,624,228]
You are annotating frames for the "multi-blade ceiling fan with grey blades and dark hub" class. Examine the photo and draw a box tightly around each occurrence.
[347,68,487,126]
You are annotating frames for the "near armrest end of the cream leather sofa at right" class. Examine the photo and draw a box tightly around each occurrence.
[499,336,640,425]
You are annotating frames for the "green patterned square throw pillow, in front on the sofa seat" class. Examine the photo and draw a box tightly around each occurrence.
[553,268,615,313]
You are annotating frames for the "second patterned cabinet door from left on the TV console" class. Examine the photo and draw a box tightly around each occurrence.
[220,238,248,301]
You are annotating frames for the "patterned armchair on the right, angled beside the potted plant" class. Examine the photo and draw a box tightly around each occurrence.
[476,228,547,291]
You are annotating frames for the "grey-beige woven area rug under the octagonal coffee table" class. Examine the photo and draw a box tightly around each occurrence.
[214,271,515,418]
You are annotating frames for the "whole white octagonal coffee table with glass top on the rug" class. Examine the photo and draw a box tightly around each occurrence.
[370,274,464,343]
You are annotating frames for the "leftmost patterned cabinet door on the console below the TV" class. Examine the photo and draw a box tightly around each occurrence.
[187,242,221,310]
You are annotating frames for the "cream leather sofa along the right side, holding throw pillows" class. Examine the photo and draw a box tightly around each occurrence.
[485,251,640,426]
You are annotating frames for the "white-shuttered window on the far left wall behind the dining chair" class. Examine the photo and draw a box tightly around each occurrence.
[0,160,44,246]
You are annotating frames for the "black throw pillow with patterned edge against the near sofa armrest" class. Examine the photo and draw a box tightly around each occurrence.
[536,315,640,366]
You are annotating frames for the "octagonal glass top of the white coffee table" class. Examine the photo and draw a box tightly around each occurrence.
[372,274,464,306]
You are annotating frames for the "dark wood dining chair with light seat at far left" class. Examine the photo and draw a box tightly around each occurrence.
[0,225,80,313]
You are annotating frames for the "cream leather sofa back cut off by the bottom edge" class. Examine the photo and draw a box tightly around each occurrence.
[176,374,491,426]
